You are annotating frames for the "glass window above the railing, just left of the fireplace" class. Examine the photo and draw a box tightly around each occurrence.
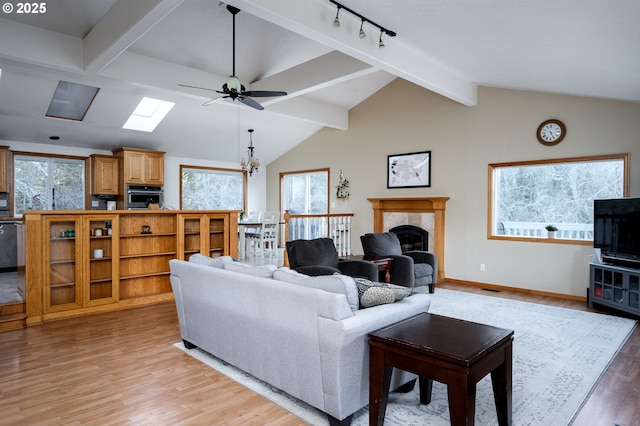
[280,169,329,214]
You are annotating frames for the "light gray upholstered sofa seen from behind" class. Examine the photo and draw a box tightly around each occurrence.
[169,255,430,425]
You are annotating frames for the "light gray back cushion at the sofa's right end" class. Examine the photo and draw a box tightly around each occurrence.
[273,268,359,312]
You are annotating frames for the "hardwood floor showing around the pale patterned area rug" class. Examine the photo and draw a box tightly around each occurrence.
[0,283,640,426]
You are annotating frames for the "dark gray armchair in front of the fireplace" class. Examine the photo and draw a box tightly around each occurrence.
[360,232,438,293]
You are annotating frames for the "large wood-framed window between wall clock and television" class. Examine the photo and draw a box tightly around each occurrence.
[489,154,628,244]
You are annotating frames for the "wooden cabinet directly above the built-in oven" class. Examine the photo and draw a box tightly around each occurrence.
[113,148,165,186]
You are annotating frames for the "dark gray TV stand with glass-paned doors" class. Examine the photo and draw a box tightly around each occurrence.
[589,263,640,315]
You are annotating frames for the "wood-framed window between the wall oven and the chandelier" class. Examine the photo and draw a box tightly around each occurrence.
[180,165,247,210]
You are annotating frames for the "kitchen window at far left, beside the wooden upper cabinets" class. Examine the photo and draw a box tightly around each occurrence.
[13,153,88,216]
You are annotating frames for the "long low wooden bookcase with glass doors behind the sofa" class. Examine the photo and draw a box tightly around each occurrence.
[24,210,238,325]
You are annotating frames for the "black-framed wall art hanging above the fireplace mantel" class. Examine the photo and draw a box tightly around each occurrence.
[387,151,431,188]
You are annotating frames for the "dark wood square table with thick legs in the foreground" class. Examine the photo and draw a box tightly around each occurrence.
[369,314,513,425]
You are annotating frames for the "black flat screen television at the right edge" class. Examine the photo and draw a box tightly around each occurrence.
[593,198,640,267]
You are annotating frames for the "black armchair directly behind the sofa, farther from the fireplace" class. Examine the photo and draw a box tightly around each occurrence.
[286,238,378,281]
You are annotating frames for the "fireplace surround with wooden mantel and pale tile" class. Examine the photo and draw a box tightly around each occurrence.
[368,197,449,280]
